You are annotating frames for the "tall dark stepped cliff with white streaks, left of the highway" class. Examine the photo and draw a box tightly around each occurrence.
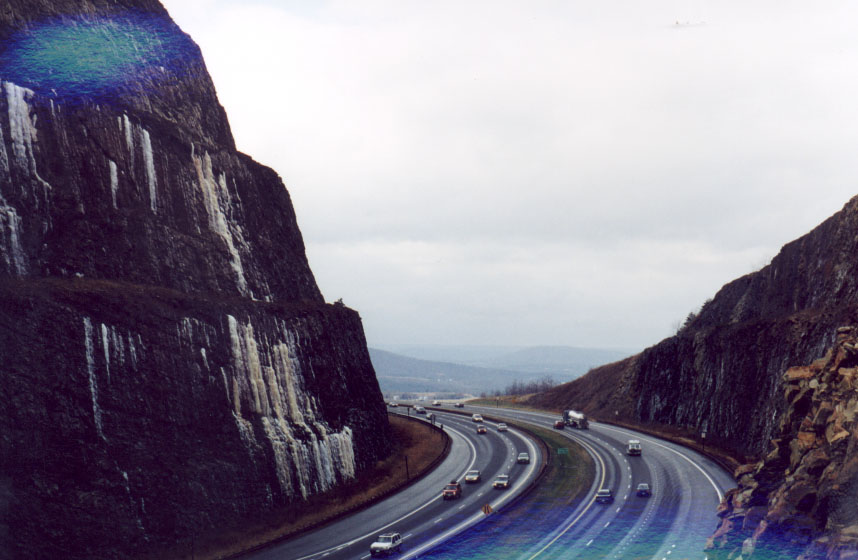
[0,0,388,558]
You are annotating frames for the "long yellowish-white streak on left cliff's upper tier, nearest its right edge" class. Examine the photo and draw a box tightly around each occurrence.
[191,149,247,295]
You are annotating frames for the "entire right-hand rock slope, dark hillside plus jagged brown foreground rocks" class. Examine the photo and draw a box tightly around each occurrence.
[531,197,858,560]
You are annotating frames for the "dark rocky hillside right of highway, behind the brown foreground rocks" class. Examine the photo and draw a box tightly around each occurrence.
[534,198,858,458]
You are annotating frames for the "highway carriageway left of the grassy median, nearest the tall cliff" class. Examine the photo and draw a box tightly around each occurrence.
[243,406,541,560]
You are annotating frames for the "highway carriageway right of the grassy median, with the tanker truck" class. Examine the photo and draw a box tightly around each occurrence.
[458,406,735,560]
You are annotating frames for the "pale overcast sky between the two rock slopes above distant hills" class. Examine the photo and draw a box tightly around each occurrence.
[162,0,858,349]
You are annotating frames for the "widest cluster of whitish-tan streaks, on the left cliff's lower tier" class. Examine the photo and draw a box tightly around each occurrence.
[224,316,355,498]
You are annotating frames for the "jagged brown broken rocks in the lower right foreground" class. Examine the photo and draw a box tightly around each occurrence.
[707,327,858,560]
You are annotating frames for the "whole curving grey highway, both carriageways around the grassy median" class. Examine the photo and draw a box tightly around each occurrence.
[246,405,735,560]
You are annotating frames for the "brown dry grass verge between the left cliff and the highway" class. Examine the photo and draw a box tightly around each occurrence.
[173,415,447,559]
